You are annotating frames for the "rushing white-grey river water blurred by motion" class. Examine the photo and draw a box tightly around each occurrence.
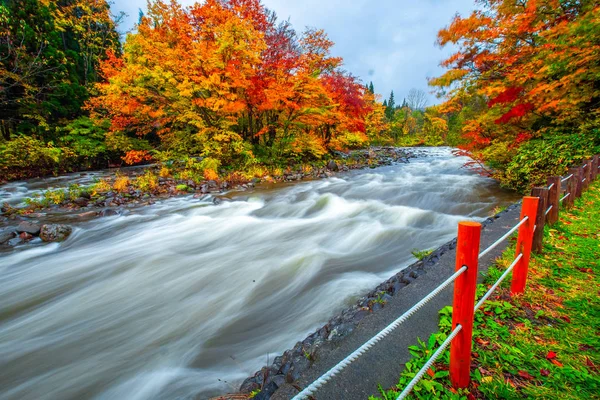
[0,149,516,400]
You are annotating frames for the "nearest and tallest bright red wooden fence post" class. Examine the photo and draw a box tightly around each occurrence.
[450,222,481,389]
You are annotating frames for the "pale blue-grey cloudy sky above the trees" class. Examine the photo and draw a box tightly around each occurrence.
[113,0,475,104]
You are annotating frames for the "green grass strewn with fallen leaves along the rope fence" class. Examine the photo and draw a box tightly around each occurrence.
[372,182,600,400]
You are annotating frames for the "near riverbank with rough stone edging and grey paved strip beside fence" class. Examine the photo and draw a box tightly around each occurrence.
[232,204,520,400]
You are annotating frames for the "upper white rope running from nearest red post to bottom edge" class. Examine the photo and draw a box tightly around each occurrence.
[292,266,468,400]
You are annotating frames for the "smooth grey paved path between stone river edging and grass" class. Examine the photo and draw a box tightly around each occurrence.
[271,206,520,400]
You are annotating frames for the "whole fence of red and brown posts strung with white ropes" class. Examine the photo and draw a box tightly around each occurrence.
[293,155,600,400]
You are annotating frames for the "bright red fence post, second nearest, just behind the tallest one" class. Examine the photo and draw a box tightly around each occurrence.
[510,197,539,295]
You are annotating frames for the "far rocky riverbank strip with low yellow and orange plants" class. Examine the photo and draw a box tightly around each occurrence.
[0,147,418,250]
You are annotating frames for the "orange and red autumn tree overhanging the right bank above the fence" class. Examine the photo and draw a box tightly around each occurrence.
[431,0,600,188]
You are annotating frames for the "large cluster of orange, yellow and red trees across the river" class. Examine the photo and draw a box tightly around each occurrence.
[89,0,384,162]
